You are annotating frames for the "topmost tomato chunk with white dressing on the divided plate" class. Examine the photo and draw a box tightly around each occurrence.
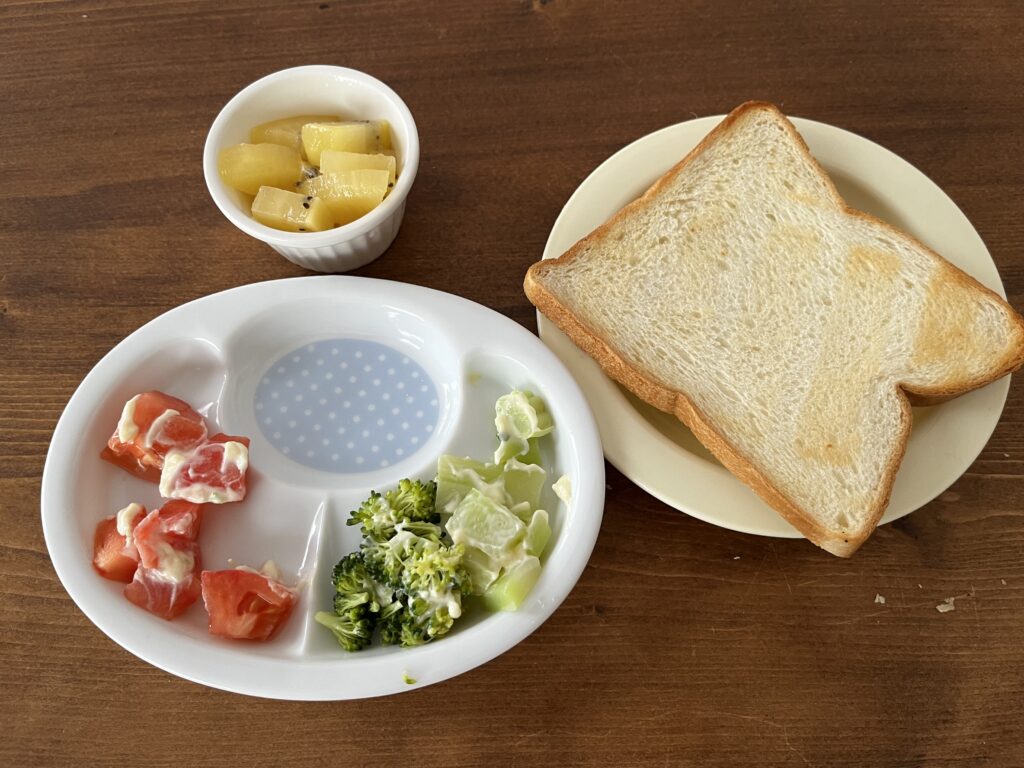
[100,391,207,482]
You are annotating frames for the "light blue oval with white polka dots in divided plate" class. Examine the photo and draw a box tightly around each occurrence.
[253,339,440,473]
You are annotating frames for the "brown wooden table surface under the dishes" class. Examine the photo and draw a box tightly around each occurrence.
[0,0,1024,767]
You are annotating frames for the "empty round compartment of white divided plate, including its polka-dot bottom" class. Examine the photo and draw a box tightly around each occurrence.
[222,295,461,492]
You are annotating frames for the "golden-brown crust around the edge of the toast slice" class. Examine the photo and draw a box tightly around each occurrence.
[523,101,1024,557]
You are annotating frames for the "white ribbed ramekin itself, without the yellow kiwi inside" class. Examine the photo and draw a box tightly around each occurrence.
[203,66,420,272]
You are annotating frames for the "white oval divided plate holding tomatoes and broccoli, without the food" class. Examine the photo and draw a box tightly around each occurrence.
[42,276,604,699]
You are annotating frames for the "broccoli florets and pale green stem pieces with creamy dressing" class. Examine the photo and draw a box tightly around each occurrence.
[315,390,554,651]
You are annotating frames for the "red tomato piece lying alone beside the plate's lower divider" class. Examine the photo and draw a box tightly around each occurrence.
[202,568,298,640]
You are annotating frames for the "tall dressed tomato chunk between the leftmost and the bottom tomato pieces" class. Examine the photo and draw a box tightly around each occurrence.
[125,501,203,620]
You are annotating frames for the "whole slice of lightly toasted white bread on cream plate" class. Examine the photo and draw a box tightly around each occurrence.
[524,102,1024,556]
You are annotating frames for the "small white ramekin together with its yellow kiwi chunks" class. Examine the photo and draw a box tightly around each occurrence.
[203,66,420,272]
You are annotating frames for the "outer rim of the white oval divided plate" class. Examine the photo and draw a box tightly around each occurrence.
[39,275,605,700]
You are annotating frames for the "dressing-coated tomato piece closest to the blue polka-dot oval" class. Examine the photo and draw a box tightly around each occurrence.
[160,434,249,504]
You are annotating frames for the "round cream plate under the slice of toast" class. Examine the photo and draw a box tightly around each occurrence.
[538,116,1010,538]
